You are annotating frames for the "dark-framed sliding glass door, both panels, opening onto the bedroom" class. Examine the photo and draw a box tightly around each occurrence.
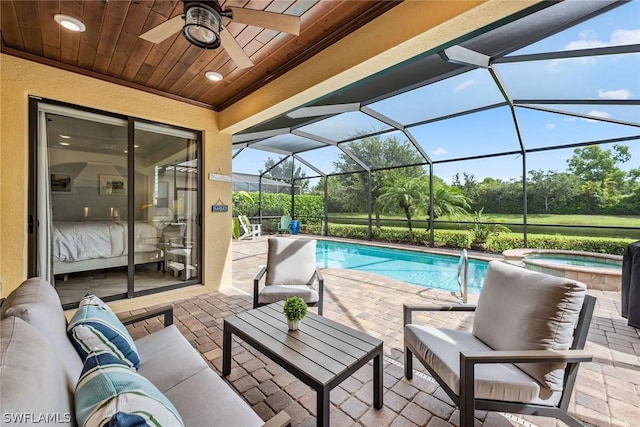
[29,99,200,306]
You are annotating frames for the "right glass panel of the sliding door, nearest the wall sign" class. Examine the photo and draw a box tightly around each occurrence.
[134,122,200,292]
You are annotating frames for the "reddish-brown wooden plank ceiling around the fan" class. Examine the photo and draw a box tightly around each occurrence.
[0,0,399,111]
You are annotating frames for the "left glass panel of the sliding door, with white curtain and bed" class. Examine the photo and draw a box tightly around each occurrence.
[43,105,128,304]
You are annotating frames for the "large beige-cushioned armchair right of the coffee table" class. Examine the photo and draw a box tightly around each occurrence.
[404,261,595,427]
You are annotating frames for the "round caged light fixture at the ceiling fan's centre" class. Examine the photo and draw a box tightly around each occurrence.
[182,2,222,49]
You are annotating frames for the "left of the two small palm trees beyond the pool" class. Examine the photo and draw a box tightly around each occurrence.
[376,176,429,230]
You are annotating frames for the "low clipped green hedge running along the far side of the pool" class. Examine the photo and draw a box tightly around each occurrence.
[301,224,633,255]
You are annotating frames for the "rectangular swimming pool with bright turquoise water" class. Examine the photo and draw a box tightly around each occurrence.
[316,240,488,293]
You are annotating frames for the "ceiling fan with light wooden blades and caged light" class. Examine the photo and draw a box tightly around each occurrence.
[140,0,300,68]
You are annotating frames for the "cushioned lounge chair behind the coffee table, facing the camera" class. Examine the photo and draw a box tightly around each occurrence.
[253,237,324,315]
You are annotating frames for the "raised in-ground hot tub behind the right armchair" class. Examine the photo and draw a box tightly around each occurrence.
[502,249,622,291]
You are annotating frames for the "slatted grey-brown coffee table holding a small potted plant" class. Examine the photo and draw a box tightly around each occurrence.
[222,302,383,426]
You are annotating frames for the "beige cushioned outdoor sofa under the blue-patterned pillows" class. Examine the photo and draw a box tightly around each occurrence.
[0,278,290,427]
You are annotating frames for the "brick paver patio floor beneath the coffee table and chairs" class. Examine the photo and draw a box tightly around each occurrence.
[122,237,640,427]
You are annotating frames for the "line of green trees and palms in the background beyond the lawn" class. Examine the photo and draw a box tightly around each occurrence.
[248,136,640,229]
